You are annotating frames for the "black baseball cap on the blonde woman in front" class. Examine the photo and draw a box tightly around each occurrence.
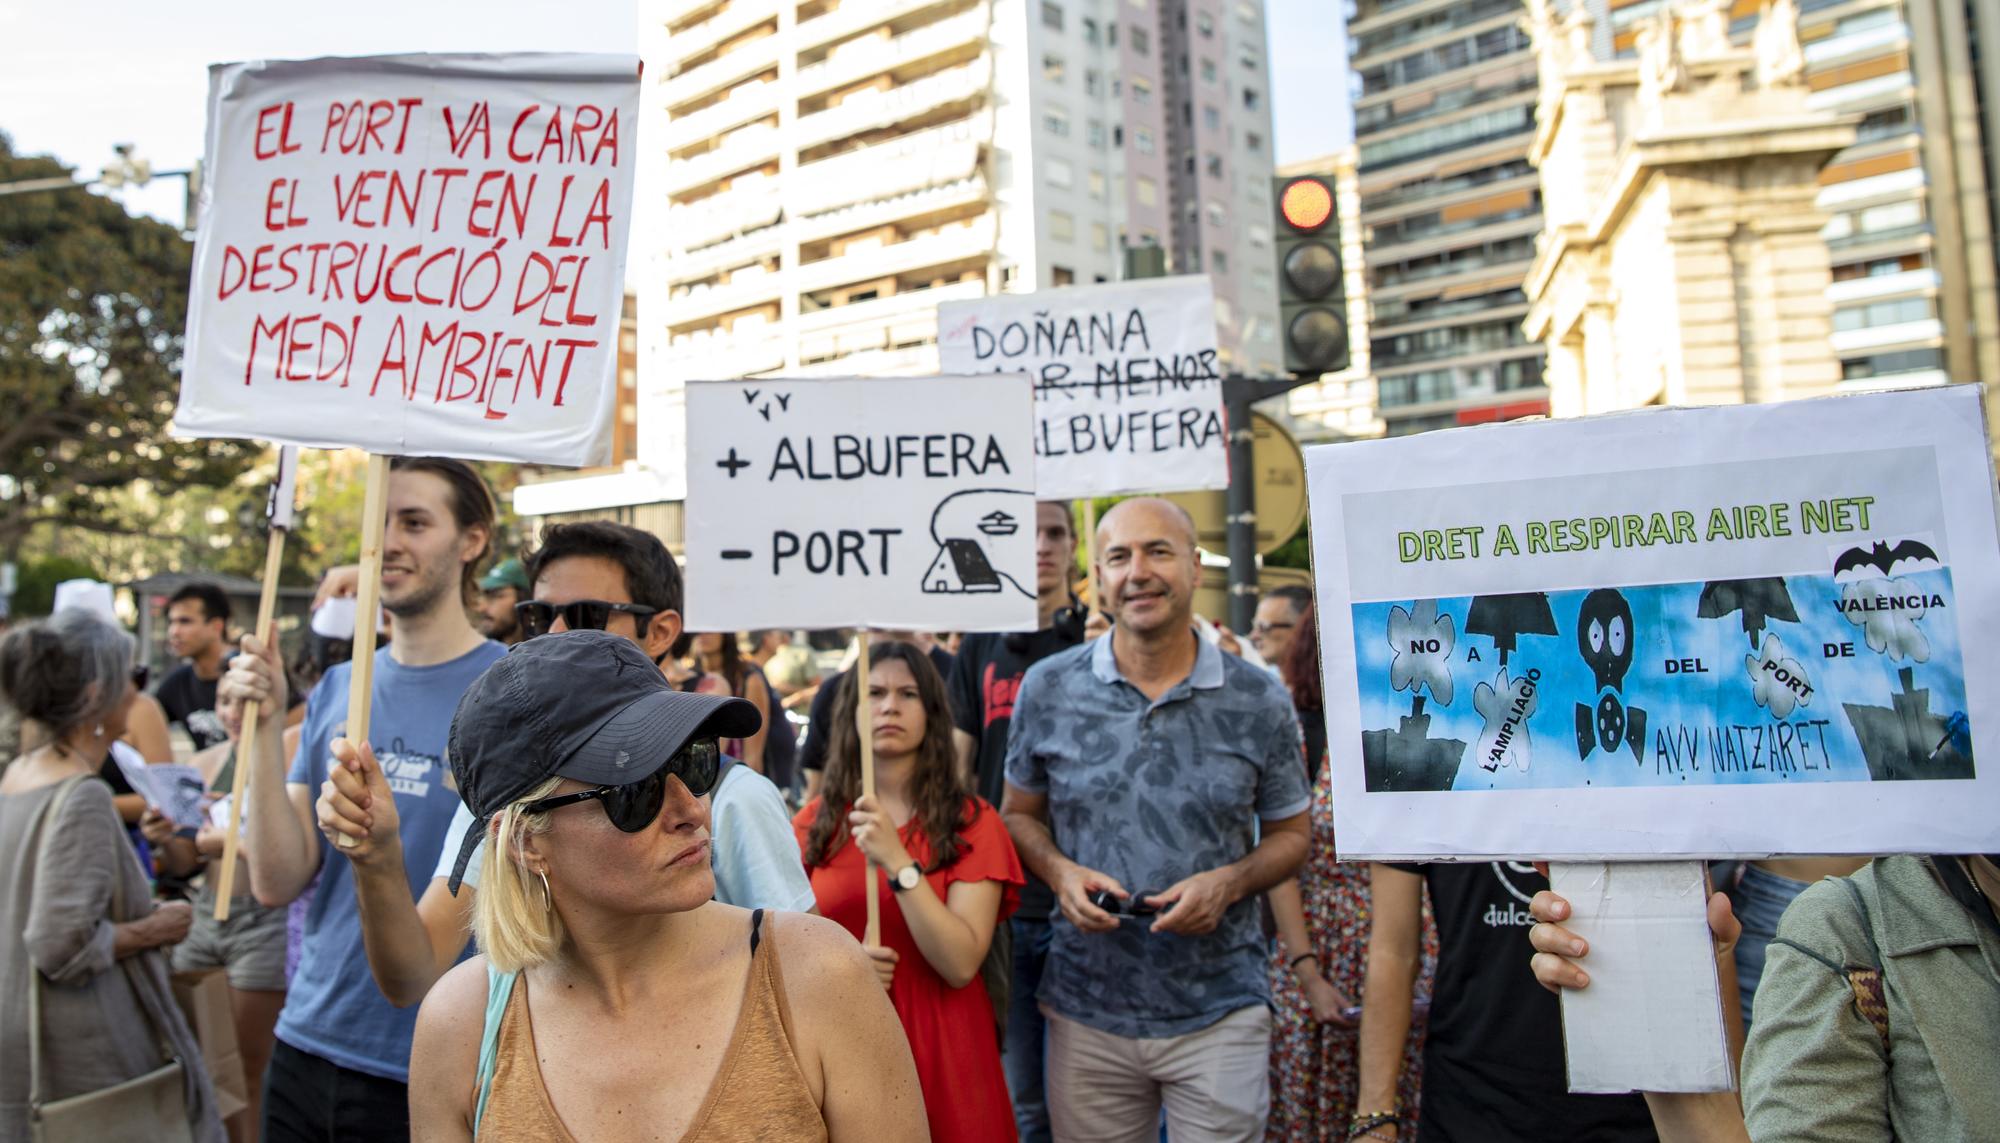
[448,631,764,895]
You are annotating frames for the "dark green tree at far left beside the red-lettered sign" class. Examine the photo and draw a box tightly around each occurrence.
[0,134,262,558]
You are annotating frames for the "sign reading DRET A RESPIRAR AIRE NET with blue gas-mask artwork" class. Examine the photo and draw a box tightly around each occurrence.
[1306,386,2000,859]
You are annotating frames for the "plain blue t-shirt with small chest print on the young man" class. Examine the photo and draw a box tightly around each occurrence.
[278,641,506,1083]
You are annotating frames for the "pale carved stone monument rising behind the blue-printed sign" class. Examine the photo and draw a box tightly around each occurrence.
[1522,0,1858,416]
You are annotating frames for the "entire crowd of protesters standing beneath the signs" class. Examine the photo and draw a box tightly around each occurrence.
[0,458,2000,1143]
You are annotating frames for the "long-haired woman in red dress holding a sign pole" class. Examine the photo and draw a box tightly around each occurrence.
[792,643,1022,1143]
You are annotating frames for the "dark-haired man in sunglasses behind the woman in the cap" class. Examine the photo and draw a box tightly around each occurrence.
[318,522,814,1005]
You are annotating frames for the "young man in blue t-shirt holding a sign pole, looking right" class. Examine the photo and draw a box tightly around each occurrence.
[222,458,506,1143]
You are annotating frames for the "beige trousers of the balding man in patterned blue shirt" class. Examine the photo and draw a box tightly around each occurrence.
[1042,1005,1270,1143]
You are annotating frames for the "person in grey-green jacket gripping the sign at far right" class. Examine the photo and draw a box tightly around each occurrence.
[1530,855,2000,1143]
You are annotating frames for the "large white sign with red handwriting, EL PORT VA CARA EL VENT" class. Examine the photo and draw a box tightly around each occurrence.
[174,54,638,466]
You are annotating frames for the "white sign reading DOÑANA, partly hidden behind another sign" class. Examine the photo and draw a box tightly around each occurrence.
[938,278,1230,500]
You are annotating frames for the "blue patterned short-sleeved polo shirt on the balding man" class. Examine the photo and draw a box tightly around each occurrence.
[1006,635,1312,1039]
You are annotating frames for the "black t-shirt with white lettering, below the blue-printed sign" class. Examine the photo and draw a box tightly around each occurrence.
[1396,861,1658,1143]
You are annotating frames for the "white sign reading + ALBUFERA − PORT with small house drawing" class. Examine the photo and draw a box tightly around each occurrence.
[686,374,1036,631]
